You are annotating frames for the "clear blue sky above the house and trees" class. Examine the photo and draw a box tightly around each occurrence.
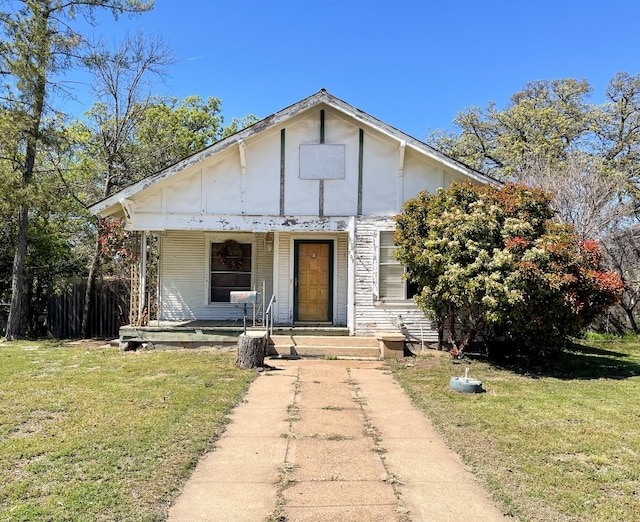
[67,0,640,139]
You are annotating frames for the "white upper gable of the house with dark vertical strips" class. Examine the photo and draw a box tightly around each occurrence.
[91,89,492,223]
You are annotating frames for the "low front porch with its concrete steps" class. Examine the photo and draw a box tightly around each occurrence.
[119,320,404,359]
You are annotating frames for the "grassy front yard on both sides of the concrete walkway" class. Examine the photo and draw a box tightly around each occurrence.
[0,336,640,522]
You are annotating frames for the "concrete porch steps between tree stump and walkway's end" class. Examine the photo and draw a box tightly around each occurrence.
[269,335,380,359]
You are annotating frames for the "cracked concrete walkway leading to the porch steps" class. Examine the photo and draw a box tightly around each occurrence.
[169,360,511,522]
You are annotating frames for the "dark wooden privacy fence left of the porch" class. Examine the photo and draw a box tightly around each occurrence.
[47,279,129,339]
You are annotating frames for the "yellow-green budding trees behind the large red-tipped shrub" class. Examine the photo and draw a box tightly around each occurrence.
[429,72,640,336]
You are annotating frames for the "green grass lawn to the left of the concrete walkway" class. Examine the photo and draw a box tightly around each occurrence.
[0,342,254,521]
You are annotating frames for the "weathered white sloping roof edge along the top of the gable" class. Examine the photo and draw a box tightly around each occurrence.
[89,89,501,214]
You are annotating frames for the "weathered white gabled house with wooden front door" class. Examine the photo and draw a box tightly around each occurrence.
[90,89,495,339]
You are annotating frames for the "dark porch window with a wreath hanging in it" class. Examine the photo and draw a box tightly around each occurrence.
[210,239,251,303]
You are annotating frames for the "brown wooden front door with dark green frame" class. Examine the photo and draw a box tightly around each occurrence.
[294,241,333,323]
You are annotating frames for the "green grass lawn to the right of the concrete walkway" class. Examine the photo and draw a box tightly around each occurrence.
[392,341,640,522]
